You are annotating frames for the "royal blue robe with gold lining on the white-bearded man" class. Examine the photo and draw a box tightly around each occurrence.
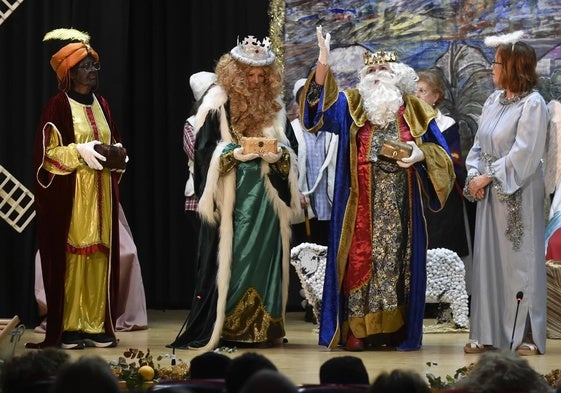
[301,71,455,350]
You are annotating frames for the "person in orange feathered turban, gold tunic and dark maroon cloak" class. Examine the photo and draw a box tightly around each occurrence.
[27,29,123,349]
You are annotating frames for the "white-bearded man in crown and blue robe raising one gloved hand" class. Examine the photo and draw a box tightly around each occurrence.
[300,26,455,351]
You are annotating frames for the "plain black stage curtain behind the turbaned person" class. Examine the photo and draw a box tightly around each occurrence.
[0,0,269,328]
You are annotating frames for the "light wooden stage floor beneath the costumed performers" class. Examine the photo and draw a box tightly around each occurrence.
[9,310,561,385]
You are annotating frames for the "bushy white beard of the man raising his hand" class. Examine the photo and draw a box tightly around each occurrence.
[358,71,403,127]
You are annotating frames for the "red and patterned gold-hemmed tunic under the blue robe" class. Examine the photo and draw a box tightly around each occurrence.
[343,122,411,338]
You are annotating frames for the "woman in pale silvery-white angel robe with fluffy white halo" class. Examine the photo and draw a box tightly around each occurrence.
[464,33,548,355]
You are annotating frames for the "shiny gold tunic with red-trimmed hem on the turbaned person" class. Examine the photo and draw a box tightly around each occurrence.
[44,97,111,255]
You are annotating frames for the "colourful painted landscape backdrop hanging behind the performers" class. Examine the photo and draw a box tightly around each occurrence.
[271,0,561,159]
